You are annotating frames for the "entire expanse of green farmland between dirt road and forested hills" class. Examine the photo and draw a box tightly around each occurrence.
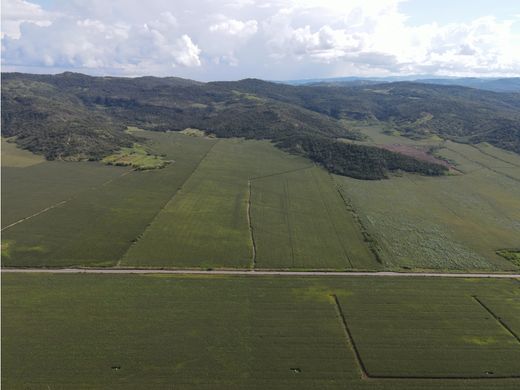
[2,125,520,271]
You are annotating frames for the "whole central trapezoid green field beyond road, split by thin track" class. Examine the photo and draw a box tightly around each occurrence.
[120,140,377,269]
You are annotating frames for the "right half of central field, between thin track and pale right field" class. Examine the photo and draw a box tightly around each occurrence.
[251,166,378,269]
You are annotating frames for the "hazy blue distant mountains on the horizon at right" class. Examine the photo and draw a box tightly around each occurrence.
[282,76,520,93]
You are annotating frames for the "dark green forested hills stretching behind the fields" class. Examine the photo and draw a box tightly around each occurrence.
[2,72,520,178]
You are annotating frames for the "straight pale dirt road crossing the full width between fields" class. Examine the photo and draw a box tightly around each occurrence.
[2,268,520,279]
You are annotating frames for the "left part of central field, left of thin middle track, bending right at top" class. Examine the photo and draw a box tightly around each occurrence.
[121,140,308,267]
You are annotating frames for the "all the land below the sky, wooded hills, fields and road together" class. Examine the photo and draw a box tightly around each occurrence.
[1,73,520,390]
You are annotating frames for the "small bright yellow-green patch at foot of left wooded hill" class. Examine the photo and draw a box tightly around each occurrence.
[101,144,172,171]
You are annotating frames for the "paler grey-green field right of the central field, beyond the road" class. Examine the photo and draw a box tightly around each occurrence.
[335,125,520,270]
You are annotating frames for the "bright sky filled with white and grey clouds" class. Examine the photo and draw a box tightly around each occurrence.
[1,0,520,81]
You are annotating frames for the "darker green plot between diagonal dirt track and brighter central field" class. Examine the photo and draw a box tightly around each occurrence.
[2,133,214,266]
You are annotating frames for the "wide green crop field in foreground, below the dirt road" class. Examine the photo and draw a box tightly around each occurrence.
[2,274,520,390]
